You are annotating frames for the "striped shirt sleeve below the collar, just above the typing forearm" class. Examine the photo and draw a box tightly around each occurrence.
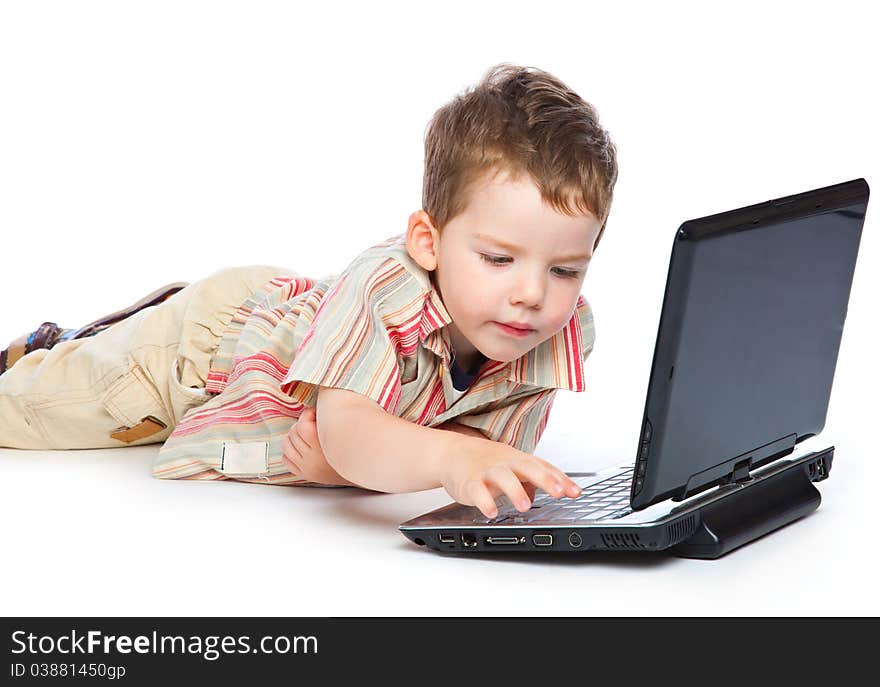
[452,387,559,453]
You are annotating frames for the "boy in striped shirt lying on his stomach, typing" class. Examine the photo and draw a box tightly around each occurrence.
[0,64,617,518]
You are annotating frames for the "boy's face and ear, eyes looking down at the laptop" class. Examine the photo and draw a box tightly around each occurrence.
[407,172,601,369]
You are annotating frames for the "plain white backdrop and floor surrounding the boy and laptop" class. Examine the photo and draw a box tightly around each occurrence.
[0,0,880,616]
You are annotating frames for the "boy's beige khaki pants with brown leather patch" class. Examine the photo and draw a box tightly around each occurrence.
[0,265,292,449]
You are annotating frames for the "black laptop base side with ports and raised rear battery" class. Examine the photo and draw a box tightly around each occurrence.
[400,446,834,559]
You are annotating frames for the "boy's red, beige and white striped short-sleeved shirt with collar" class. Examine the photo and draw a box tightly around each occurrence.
[153,234,595,485]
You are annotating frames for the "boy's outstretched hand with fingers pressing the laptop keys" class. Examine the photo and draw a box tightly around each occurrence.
[441,437,581,518]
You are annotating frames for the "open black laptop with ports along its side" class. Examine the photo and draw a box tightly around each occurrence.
[400,179,869,558]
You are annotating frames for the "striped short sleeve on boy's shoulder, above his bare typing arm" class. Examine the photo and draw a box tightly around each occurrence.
[281,258,402,414]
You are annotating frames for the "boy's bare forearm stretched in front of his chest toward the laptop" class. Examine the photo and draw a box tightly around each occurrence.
[318,404,486,493]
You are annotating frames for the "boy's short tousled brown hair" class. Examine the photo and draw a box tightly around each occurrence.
[422,62,617,253]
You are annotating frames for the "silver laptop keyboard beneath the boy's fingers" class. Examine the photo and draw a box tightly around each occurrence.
[484,467,633,524]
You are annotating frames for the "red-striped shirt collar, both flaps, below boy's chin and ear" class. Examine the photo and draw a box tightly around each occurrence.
[419,278,593,391]
